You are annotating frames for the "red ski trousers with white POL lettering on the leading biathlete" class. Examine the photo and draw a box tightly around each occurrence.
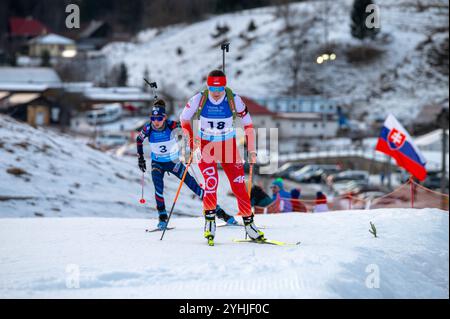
[198,139,252,217]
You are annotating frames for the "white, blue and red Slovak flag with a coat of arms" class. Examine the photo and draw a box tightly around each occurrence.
[376,114,427,181]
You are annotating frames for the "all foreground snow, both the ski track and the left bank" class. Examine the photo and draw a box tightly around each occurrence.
[0,116,449,298]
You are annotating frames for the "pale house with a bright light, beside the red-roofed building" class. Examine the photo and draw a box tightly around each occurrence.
[28,33,77,58]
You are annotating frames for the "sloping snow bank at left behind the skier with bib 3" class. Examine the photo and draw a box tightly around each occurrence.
[0,115,237,218]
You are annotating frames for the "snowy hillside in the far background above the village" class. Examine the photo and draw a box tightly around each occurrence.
[103,0,448,120]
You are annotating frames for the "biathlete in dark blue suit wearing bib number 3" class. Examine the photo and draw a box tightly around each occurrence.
[136,100,237,229]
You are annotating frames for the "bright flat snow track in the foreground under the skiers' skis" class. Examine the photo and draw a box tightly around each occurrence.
[0,209,449,298]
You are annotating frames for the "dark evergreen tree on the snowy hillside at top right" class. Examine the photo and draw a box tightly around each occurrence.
[351,0,380,40]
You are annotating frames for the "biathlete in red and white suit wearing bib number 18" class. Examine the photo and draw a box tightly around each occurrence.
[181,70,264,245]
